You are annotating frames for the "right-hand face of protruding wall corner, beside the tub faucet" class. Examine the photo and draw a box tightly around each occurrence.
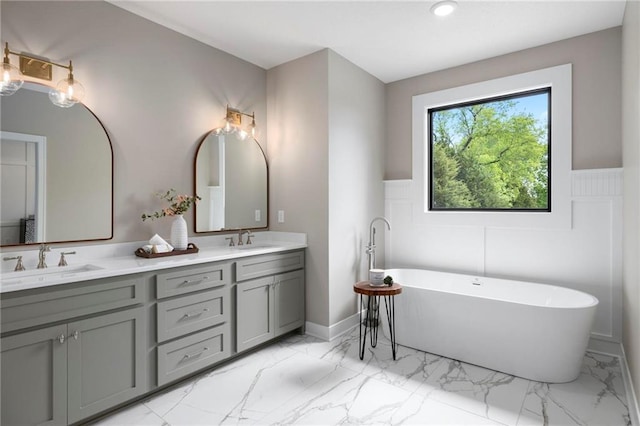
[328,51,385,325]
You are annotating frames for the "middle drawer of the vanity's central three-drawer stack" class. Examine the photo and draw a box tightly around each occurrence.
[157,286,230,342]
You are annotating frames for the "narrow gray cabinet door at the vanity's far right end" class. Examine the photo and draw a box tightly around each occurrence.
[275,271,304,336]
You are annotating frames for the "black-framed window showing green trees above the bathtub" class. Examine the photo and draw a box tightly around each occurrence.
[428,88,551,211]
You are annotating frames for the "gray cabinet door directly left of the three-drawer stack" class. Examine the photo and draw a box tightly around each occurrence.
[67,307,145,423]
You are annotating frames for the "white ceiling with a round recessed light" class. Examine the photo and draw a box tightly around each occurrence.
[110,0,624,83]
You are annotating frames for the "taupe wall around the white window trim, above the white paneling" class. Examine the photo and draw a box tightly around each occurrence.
[385,27,622,179]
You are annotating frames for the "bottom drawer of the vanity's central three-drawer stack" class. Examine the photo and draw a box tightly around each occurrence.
[158,322,231,386]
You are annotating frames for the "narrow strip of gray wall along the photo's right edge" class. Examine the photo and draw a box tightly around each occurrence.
[622,1,640,409]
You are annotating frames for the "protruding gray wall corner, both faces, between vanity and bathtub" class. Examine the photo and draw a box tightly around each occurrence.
[267,49,384,327]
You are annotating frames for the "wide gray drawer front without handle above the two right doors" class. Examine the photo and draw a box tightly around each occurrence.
[236,250,304,281]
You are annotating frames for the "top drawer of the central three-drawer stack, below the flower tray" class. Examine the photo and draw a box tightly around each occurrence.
[156,263,231,299]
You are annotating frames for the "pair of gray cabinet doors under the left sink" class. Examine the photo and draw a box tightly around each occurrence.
[1,308,144,425]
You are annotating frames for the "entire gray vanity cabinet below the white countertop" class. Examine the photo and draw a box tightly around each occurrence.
[0,250,304,426]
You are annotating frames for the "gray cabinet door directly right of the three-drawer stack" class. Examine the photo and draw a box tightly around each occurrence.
[236,277,275,352]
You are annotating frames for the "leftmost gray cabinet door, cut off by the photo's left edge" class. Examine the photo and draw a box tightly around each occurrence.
[0,325,67,425]
